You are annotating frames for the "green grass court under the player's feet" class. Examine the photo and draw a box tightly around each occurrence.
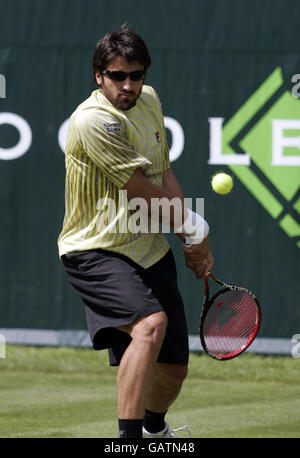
[0,345,300,438]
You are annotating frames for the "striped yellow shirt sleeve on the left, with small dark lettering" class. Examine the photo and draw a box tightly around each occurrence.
[75,111,151,188]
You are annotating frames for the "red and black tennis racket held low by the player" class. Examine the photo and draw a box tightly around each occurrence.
[199,273,261,360]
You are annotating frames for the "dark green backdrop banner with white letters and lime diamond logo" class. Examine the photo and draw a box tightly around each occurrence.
[0,0,300,351]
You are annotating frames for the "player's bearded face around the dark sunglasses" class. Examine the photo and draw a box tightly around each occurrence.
[95,56,144,110]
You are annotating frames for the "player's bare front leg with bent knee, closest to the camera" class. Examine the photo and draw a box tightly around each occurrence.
[118,312,168,437]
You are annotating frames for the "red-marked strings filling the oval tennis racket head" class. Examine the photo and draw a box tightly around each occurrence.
[203,291,258,358]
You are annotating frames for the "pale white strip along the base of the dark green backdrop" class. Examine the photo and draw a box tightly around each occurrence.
[0,328,293,355]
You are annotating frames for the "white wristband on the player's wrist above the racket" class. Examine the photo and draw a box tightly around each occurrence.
[176,208,209,245]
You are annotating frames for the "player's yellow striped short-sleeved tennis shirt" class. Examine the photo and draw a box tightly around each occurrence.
[58,85,170,268]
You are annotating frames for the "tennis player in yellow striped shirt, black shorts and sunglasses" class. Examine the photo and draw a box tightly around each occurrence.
[58,26,213,438]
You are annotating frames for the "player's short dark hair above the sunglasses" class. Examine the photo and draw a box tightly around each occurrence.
[93,24,151,77]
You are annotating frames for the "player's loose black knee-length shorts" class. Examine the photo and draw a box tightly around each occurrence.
[62,249,189,366]
